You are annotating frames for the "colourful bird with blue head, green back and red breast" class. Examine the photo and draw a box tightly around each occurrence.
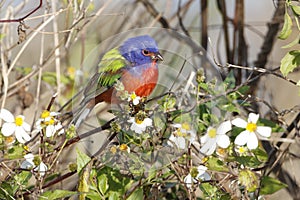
[71,35,163,128]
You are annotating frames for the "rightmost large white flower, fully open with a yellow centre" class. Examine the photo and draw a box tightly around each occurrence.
[231,113,272,150]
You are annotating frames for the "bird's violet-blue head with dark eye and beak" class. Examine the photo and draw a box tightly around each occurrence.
[119,35,163,66]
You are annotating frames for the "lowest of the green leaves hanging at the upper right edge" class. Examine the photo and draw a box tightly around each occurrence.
[280,50,300,76]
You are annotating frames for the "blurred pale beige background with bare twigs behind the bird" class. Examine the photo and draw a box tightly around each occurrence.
[0,0,300,199]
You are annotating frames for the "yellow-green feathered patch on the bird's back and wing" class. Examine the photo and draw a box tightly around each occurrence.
[98,48,127,87]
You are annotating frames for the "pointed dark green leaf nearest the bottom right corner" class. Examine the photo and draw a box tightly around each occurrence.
[260,176,287,195]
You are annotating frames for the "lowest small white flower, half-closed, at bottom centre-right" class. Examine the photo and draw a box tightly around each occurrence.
[184,165,210,188]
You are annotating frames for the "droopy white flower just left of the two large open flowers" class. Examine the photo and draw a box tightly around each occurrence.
[167,123,196,149]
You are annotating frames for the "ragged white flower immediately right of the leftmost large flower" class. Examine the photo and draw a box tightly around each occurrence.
[36,110,64,137]
